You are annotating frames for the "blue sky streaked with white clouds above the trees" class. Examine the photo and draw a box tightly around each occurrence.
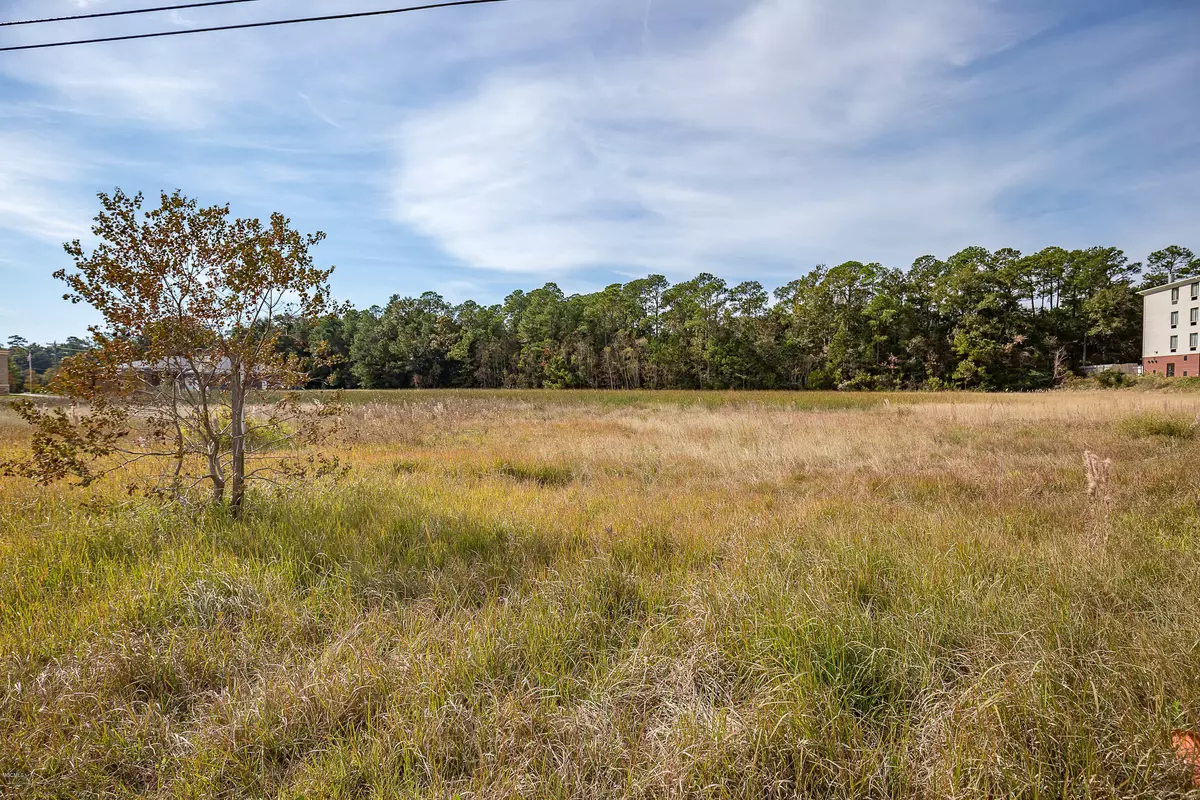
[0,0,1200,341]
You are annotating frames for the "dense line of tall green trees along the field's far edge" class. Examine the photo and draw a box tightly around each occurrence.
[11,246,1200,391]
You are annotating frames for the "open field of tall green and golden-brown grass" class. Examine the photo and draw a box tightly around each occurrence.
[0,391,1200,799]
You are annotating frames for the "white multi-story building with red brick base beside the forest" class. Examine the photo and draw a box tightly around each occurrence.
[1141,276,1200,378]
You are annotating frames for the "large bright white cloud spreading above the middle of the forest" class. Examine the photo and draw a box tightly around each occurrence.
[395,0,1030,271]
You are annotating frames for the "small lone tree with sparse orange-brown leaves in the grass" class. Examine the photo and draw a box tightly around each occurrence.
[5,190,340,515]
